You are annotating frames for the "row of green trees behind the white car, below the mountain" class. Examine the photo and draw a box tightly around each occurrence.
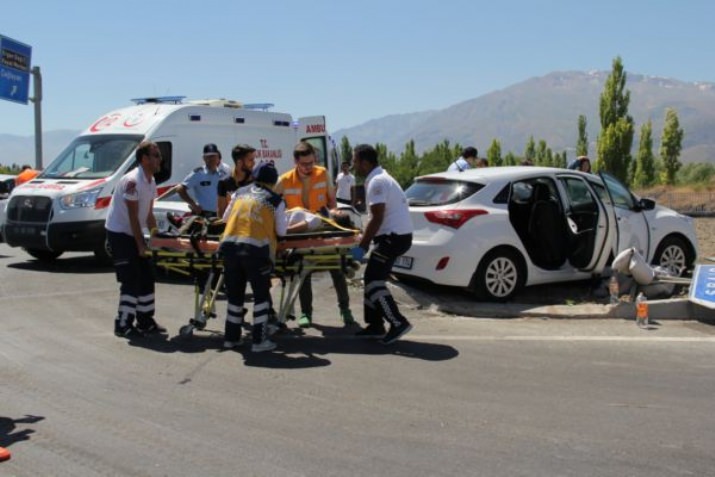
[339,57,715,189]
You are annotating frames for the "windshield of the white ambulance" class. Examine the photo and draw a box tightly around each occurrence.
[39,135,143,179]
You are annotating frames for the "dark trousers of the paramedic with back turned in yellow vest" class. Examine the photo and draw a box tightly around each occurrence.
[221,243,273,344]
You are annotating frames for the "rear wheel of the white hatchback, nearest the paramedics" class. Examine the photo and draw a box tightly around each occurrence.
[472,248,526,302]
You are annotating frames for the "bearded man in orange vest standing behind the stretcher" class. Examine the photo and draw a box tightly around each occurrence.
[275,141,355,328]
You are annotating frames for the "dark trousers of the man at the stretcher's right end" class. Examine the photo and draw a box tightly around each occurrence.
[363,234,412,326]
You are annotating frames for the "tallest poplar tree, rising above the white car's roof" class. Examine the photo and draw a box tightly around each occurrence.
[595,56,634,183]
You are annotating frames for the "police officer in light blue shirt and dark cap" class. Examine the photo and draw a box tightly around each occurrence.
[176,144,231,217]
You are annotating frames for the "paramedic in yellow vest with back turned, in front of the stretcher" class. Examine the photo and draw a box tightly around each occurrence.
[219,162,286,353]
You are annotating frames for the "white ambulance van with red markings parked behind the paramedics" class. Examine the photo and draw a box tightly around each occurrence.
[1,96,338,263]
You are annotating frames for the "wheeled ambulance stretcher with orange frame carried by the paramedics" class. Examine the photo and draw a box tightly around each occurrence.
[148,230,360,336]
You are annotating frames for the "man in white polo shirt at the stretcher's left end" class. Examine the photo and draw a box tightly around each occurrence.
[105,141,166,338]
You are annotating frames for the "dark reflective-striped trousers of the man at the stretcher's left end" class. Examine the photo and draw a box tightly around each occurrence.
[107,230,155,329]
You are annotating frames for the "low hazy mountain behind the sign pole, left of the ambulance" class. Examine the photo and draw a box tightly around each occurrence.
[0,129,79,167]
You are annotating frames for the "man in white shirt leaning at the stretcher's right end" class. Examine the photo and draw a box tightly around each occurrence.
[352,144,412,345]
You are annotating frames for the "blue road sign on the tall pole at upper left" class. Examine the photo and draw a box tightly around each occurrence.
[0,35,32,104]
